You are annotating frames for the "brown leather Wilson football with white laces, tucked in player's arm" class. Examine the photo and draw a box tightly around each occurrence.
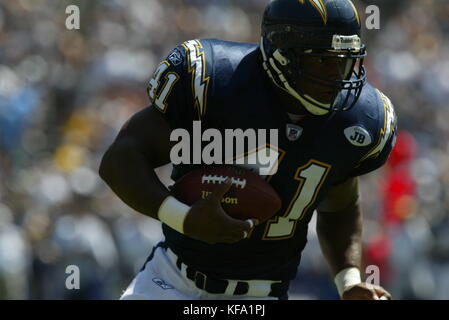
[172,165,282,223]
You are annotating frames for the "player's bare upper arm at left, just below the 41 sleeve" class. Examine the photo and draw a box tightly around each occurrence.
[113,107,173,168]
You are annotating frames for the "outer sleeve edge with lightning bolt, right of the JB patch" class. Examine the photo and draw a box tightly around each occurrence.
[350,91,397,177]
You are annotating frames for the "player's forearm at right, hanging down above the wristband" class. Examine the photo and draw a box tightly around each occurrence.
[317,202,362,276]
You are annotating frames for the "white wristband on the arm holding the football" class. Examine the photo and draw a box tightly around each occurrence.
[157,196,190,233]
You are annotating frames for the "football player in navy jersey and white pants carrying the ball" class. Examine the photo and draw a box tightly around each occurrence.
[100,0,396,300]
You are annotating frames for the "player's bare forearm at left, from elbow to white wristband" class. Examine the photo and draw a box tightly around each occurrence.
[100,143,169,219]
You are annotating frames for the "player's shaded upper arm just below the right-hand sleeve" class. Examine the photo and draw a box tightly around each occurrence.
[317,177,360,212]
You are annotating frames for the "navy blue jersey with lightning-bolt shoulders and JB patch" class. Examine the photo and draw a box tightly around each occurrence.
[148,39,396,280]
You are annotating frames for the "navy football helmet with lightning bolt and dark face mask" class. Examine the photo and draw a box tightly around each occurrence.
[260,0,366,115]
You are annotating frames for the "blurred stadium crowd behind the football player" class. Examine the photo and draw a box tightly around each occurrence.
[0,0,449,299]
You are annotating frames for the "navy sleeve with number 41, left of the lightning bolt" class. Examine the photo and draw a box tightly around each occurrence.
[147,45,196,128]
